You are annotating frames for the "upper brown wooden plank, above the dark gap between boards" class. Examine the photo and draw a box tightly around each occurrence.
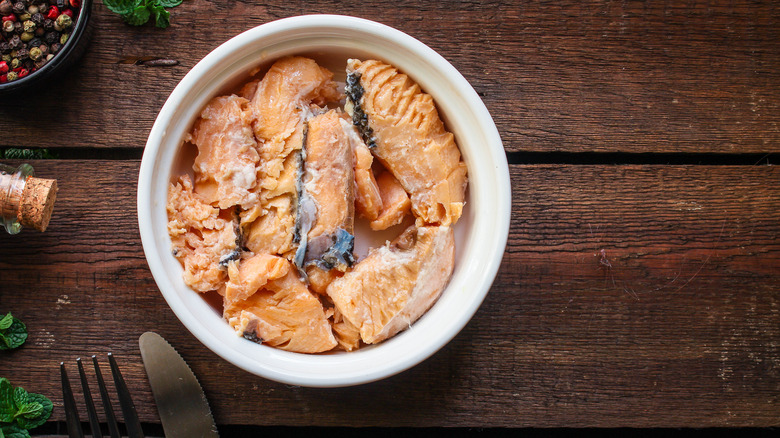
[0,0,780,153]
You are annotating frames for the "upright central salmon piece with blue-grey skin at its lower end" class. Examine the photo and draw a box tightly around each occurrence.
[294,110,355,278]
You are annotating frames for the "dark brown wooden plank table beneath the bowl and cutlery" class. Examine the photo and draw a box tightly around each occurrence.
[0,0,780,436]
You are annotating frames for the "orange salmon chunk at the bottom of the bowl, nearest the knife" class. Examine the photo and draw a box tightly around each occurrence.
[223,256,338,353]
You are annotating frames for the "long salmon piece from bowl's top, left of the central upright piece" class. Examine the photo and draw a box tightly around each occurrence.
[241,56,341,256]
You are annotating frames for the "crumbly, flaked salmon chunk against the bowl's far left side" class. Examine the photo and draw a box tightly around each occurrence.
[167,175,240,292]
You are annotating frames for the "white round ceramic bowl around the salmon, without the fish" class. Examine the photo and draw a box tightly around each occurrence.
[138,15,511,387]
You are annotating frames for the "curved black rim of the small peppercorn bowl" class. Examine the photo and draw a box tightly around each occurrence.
[0,0,92,94]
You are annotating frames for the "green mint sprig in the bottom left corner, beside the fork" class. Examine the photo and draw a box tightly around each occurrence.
[0,377,54,438]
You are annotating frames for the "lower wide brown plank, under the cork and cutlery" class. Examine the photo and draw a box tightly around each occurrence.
[0,160,780,427]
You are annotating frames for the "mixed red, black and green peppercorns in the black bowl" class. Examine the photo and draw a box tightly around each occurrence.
[0,0,81,83]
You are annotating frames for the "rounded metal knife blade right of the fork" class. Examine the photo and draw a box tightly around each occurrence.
[138,332,219,438]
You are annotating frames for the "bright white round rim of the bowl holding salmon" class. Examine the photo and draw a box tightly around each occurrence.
[137,14,511,387]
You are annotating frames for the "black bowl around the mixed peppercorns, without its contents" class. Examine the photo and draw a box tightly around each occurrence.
[0,0,92,96]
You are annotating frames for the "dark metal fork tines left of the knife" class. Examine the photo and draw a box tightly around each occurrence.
[60,353,144,438]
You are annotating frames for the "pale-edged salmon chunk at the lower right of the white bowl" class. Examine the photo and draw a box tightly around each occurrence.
[326,226,455,344]
